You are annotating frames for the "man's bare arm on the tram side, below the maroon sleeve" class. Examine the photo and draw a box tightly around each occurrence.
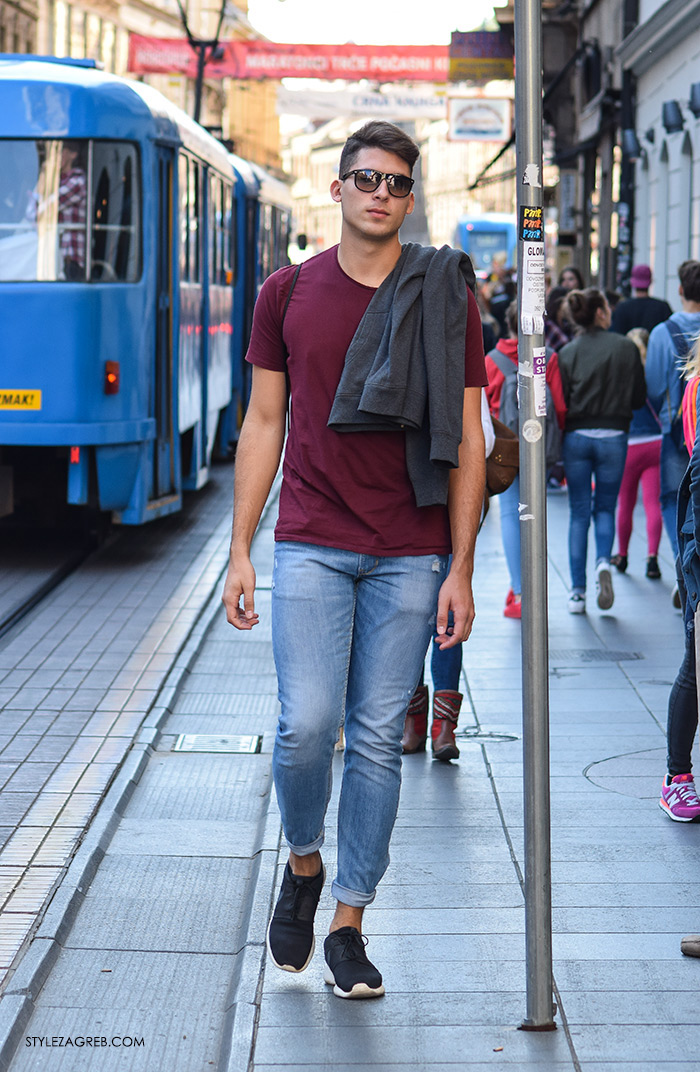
[222,366,287,629]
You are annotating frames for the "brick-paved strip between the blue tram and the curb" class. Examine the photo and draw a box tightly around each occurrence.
[0,466,233,987]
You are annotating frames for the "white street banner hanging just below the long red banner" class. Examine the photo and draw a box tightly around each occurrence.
[277,86,447,120]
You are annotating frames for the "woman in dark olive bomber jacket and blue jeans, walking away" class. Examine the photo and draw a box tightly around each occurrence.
[558,286,646,614]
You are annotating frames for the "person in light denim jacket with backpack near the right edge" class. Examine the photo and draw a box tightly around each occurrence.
[645,260,700,561]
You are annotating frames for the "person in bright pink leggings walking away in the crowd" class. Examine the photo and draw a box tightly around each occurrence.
[611,328,662,580]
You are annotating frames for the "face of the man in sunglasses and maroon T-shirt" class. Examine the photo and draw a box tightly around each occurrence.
[330,149,415,241]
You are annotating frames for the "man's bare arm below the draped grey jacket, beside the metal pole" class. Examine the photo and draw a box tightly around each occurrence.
[436,387,486,649]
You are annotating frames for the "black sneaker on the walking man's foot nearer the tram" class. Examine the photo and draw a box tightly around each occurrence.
[267,862,326,971]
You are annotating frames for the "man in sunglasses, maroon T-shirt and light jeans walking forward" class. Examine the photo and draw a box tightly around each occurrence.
[223,122,486,998]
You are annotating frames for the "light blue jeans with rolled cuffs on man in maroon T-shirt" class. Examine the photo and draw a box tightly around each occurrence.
[272,541,447,908]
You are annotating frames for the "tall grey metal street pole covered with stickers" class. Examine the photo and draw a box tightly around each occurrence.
[515,0,556,1031]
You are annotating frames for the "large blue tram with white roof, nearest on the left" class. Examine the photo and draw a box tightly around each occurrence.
[0,57,289,524]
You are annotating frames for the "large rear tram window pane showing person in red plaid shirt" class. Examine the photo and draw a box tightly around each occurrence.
[0,139,88,282]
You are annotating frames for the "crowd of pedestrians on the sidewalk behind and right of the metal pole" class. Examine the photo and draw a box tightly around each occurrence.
[480,260,700,870]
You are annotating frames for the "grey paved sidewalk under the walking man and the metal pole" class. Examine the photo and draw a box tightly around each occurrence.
[9,494,700,1072]
